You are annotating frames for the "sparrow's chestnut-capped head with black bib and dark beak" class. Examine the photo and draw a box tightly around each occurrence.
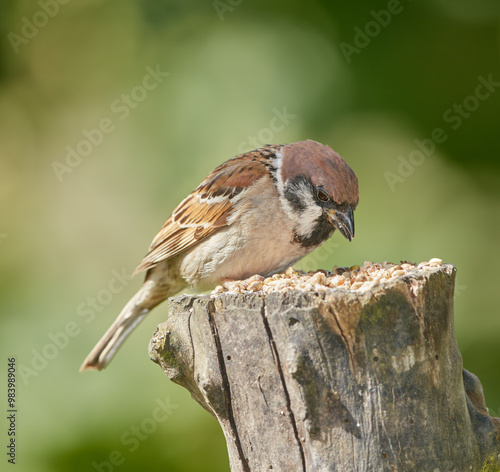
[277,140,359,246]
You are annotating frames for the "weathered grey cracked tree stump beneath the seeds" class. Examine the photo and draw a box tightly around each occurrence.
[150,264,500,472]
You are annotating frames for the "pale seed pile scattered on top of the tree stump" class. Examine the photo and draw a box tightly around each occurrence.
[212,258,443,294]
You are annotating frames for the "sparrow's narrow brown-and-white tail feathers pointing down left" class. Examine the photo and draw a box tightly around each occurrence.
[80,288,151,372]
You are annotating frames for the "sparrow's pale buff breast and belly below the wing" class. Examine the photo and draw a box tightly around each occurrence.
[180,178,315,289]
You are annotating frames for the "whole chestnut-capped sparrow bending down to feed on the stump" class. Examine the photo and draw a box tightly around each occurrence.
[80,140,359,371]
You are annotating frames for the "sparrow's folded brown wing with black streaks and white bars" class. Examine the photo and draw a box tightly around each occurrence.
[135,148,271,273]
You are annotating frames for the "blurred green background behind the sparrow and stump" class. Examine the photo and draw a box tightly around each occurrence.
[0,0,500,472]
